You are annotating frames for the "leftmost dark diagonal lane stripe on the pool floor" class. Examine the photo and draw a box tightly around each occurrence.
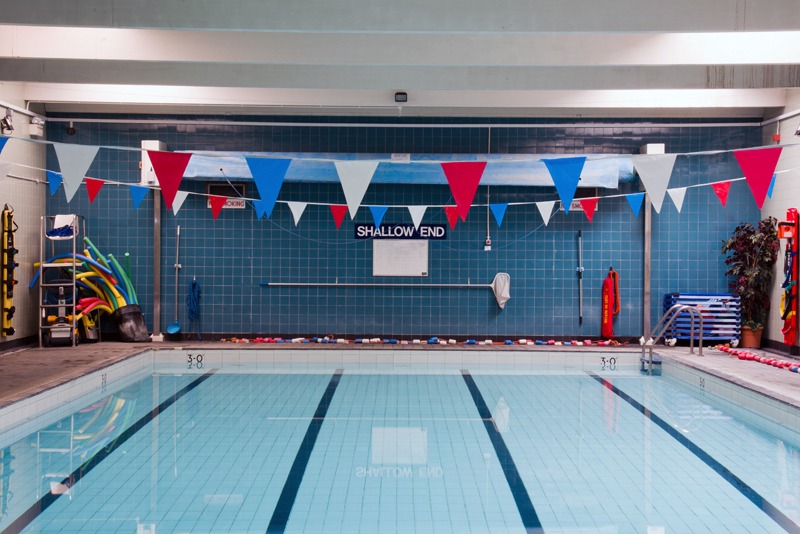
[3,369,217,534]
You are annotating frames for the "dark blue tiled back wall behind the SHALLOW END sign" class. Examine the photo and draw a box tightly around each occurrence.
[47,116,761,339]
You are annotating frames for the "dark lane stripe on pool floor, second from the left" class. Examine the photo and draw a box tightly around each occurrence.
[267,369,344,534]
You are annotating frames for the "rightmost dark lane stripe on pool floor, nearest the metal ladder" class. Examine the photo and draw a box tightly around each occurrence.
[589,373,800,533]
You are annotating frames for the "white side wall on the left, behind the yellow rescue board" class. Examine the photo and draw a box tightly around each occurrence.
[0,82,47,350]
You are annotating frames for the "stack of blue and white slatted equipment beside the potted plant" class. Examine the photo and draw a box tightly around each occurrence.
[664,293,742,342]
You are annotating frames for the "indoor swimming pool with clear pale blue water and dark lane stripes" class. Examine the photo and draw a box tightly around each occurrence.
[0,350,800,534]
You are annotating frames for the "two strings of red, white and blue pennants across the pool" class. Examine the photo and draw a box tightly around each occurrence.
[0,137,800,229]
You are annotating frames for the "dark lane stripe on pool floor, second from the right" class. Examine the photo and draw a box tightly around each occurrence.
[461,369,544,533]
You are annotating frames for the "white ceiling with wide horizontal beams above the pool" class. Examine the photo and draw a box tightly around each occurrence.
[0,0,800,117]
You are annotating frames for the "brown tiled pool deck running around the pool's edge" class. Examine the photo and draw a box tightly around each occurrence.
[0,341,800,409]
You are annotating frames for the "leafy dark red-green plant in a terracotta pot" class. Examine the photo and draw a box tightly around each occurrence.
[722,217,780,348]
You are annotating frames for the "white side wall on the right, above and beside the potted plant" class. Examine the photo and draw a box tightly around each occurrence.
[761,89,800,345]
